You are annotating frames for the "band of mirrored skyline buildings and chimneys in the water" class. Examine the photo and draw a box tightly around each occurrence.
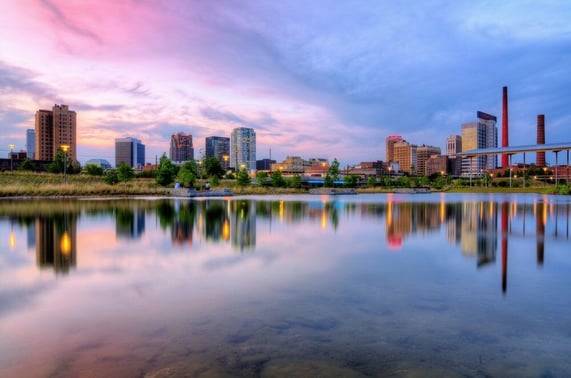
[0,195,570,292]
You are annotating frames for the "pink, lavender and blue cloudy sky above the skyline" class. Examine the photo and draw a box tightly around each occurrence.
[0,0,571,165]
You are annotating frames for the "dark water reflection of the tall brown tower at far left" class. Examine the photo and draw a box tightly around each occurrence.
[36,213,77,273]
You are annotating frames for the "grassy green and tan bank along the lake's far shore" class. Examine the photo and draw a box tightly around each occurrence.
[0,172,568,197]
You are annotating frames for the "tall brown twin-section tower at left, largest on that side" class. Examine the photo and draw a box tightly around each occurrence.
[34,104,77,161]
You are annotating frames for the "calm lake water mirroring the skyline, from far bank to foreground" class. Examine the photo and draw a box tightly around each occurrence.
[0,194,571,377]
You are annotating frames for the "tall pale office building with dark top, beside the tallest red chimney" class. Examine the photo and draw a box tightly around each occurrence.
[462,112,498,176]
